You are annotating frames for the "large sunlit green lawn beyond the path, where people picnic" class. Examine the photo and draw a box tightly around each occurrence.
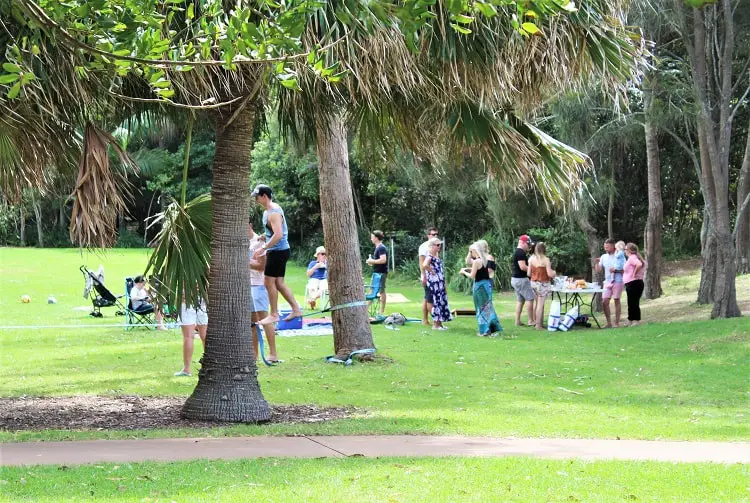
[0,248,750,441]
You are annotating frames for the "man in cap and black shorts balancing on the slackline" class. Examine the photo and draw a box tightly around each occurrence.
[250,184,302,325]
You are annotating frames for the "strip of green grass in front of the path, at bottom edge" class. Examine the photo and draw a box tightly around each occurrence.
[0,458,750,503]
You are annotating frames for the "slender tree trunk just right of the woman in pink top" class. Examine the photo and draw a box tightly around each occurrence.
[644,90,664,299]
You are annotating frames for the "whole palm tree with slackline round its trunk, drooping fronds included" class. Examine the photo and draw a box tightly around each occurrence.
[279,0,640,357]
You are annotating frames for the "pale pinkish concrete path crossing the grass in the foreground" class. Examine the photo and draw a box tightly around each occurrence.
[0,436,750,466]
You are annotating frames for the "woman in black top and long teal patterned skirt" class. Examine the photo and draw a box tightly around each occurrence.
[461,239,503,337]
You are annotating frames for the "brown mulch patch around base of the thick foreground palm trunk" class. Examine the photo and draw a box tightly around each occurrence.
[0,396,356,431]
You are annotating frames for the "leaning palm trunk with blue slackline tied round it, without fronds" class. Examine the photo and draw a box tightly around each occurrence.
[316,113,375,358]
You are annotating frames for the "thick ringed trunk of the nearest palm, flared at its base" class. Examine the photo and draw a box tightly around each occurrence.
[182,103,270,423]
